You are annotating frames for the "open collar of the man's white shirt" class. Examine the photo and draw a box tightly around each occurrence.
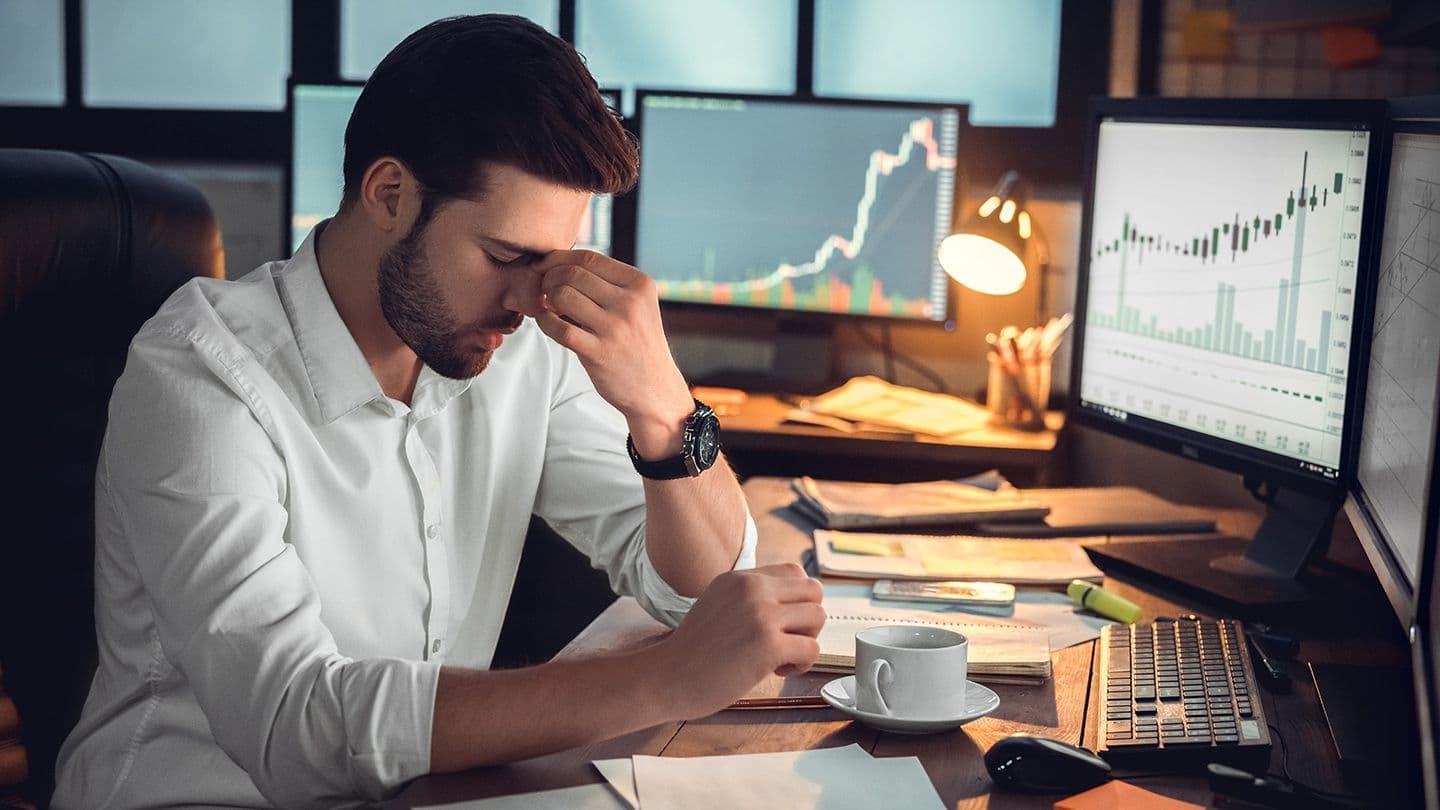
[276,219,471,424]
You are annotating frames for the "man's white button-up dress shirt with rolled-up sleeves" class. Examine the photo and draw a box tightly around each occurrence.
[55,227,755,810]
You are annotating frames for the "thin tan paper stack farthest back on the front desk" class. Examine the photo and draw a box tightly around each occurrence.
[791,476,1050,529]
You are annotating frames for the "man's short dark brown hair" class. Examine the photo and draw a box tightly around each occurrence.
[341,14,639,208]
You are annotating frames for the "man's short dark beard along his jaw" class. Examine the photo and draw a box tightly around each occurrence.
[377,214,521,379]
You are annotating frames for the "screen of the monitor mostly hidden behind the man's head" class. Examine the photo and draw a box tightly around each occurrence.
[285,82,619,255]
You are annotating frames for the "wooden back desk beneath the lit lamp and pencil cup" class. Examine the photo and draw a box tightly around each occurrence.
[720,393,1064,487]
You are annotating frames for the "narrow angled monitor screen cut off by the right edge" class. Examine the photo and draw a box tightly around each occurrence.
[1346,123,1440,623]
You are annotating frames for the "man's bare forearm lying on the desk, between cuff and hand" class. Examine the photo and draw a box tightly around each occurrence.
[431,646,685,773]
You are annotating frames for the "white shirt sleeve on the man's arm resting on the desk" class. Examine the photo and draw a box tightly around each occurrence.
[105,325,439,807]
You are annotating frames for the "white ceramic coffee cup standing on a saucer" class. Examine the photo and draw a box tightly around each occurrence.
[855,624,969,719]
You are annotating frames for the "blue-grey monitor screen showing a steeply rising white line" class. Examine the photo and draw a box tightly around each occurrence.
[635,91,960,321]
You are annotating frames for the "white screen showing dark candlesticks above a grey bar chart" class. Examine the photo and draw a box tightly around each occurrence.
[1084,121,1371,470]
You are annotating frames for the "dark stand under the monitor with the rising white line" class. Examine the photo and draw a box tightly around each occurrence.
[691,317,841,396]
